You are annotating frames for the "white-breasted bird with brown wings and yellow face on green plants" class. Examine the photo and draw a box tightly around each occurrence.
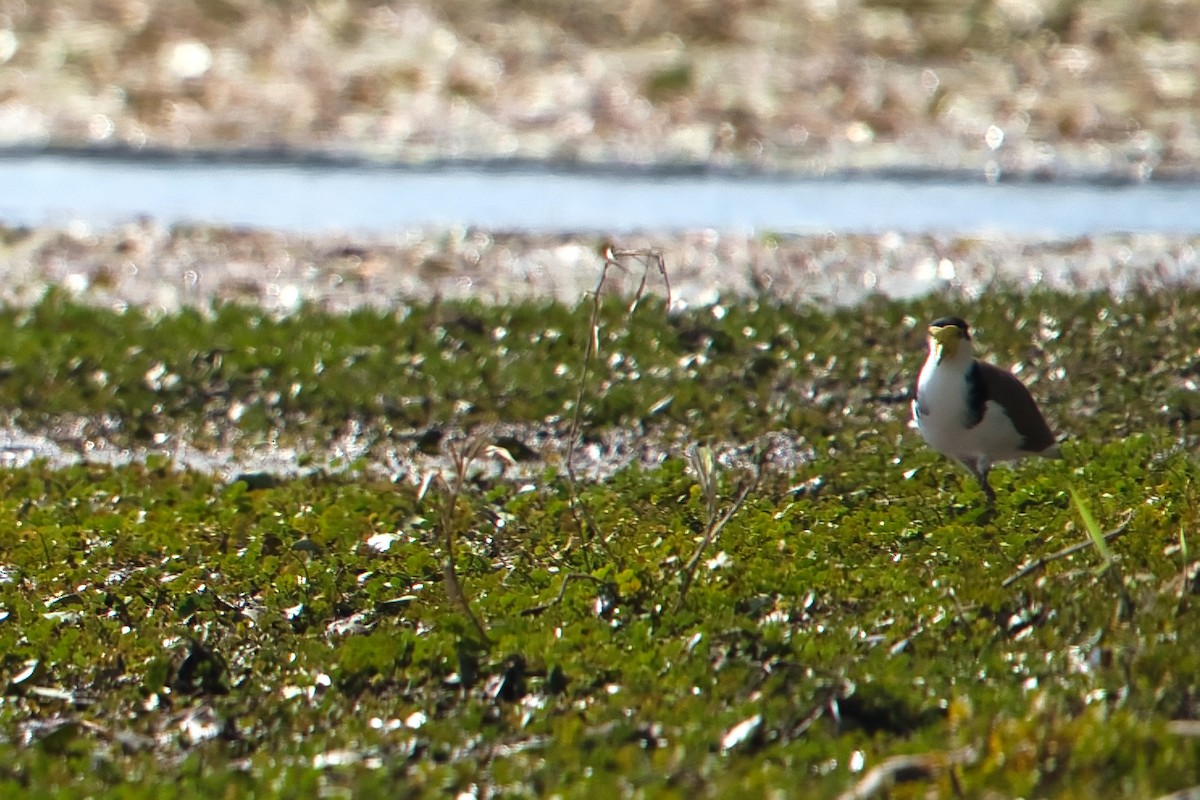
[912,317,1062,509]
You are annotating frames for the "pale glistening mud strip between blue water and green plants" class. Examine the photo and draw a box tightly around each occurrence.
[0,221,1200,313]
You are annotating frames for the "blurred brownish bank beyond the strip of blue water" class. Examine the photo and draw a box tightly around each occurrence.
[0,0,1200,178]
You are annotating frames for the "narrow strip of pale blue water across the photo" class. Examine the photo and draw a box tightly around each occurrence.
[0,152,1200,236]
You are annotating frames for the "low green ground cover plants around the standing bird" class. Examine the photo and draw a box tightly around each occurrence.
[0,288,1200,798]
